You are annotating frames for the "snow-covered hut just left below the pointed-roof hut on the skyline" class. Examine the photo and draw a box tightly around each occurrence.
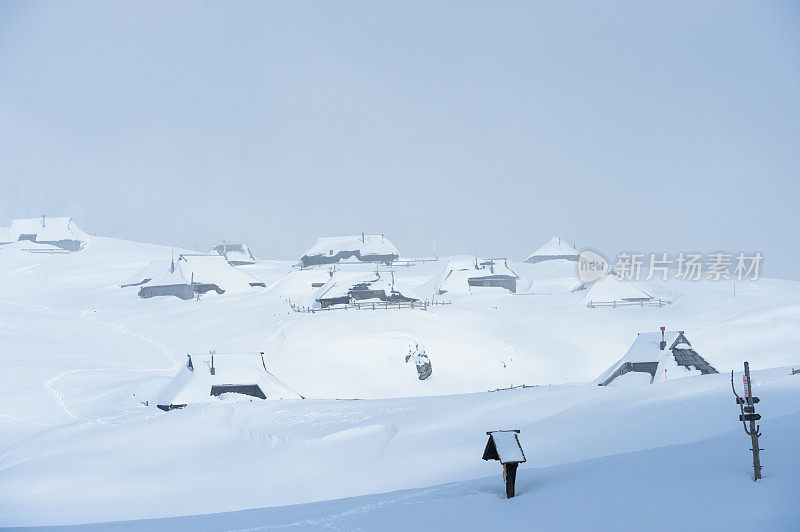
[437,258,519,294]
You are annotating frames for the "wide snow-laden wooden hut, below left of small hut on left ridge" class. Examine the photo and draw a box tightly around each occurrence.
[133,254,264,299]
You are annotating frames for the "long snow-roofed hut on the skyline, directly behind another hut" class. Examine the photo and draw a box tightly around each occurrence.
[300,233,400,267]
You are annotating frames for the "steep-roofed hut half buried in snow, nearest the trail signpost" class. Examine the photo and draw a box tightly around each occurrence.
[594,331,718,386]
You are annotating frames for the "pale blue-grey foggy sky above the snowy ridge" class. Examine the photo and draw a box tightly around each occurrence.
[0,0,800,279]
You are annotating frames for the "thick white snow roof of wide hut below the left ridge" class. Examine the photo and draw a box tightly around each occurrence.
[139,255,261,292]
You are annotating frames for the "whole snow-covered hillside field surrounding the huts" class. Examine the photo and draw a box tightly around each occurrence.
[0,237,800,530]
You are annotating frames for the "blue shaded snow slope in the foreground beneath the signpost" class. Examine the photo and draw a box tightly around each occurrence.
[37,414,800,532]
